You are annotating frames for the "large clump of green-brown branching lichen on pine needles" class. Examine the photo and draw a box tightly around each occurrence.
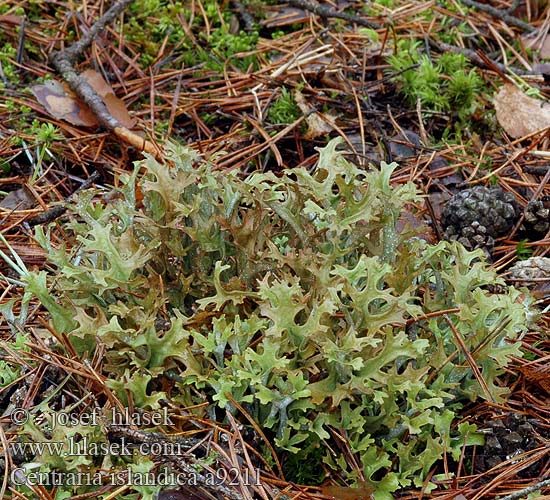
[9,140,536,498]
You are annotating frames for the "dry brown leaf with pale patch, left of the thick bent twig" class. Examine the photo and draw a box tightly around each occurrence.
[31,80,99,127]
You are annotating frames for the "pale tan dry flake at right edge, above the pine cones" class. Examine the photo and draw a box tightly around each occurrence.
[493,83,550,139]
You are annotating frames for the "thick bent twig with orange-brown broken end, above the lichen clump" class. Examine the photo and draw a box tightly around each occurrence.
[50,0,159,155]
